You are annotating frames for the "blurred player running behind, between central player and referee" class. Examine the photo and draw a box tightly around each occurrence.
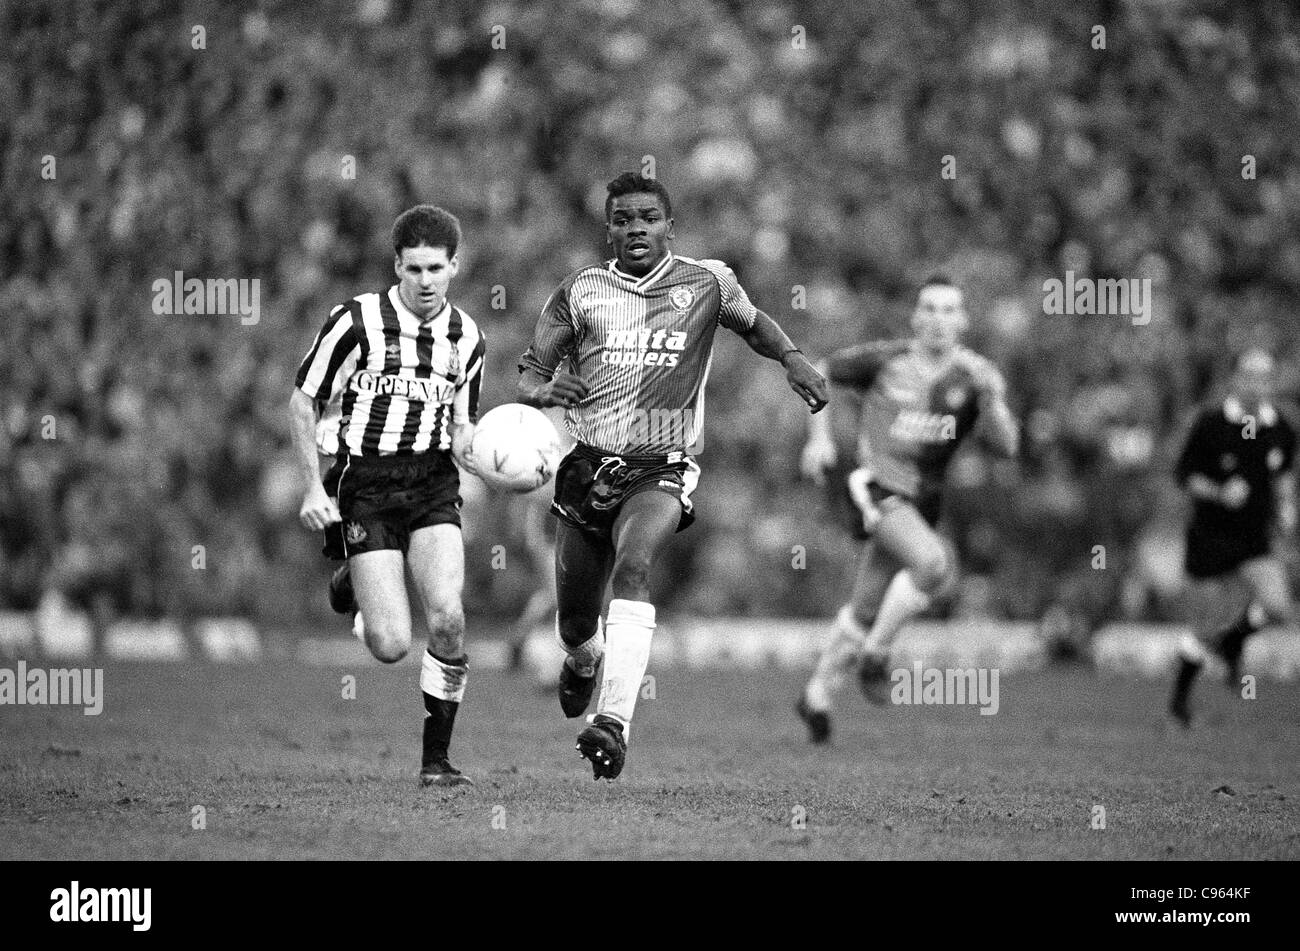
[796,274,1019,743]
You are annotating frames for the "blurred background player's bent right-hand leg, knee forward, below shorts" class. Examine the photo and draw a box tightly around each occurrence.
[858,499,956,704]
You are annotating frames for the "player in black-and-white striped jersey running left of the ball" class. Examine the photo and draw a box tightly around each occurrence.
[290,205,484,786]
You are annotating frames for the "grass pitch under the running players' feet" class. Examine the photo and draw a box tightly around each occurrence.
[0,663,1300,860]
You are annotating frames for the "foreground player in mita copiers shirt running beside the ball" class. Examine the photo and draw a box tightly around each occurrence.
[519,171,827,780]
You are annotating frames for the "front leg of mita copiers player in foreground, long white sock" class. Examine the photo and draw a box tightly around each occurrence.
[577,491,681,780]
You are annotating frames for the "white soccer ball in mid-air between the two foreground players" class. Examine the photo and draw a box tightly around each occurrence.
[469,403,562,492]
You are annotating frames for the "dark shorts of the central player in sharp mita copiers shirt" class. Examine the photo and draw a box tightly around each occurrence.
[551,443,699,538]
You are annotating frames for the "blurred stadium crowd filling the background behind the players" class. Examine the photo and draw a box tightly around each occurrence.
[0,0,1300,646]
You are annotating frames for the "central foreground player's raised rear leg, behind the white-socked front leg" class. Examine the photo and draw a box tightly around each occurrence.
[555,521,614,717]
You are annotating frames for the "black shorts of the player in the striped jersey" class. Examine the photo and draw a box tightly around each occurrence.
[322,451,460,560]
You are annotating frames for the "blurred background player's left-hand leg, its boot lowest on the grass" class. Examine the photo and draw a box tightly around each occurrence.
[796,539,894,743]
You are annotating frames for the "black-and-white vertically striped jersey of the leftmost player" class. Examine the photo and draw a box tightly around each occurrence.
[295,285,485,456]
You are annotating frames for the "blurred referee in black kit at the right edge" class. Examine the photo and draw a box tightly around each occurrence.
[1169,349,1296,726]
